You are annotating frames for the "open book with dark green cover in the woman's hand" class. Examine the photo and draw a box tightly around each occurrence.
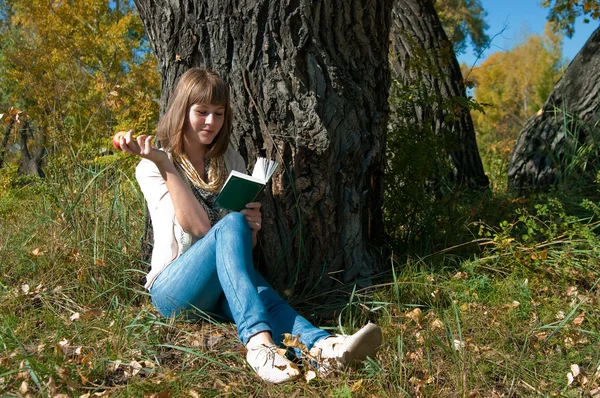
[215,158,278,211]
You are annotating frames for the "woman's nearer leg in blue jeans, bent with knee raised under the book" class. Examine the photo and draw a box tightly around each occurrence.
[150,213,271,344]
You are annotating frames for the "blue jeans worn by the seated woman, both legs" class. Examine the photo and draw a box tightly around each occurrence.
[150,213,329,349]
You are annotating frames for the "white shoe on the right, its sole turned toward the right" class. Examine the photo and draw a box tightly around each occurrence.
[309,323,382,376]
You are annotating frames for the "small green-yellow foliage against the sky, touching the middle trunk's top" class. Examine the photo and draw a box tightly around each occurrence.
[435,0,490,53]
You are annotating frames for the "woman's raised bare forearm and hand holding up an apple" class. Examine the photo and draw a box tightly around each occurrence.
[120,130,210,238]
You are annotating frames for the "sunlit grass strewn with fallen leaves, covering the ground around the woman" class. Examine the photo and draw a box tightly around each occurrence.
[0,141,600,397]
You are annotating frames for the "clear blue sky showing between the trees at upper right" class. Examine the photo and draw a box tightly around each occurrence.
[458,0,599,66]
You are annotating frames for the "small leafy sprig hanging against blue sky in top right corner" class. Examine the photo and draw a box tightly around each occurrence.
[542,0,600,37]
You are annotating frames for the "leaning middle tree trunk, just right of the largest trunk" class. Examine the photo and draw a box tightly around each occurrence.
[391,0,489,188]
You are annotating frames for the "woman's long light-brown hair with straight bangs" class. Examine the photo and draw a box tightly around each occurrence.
[156,68,233,158]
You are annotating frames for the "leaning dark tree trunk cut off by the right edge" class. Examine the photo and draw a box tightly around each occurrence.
[508,28,600,190]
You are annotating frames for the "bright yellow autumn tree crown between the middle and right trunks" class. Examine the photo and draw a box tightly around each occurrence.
[469,26,563,140]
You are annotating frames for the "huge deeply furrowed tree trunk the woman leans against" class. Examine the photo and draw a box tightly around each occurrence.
[135,0,392,288]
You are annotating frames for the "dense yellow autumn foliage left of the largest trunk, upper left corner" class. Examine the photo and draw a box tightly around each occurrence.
[0,0,159,170]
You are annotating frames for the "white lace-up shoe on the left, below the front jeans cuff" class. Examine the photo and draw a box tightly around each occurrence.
[246,343,300,384]
